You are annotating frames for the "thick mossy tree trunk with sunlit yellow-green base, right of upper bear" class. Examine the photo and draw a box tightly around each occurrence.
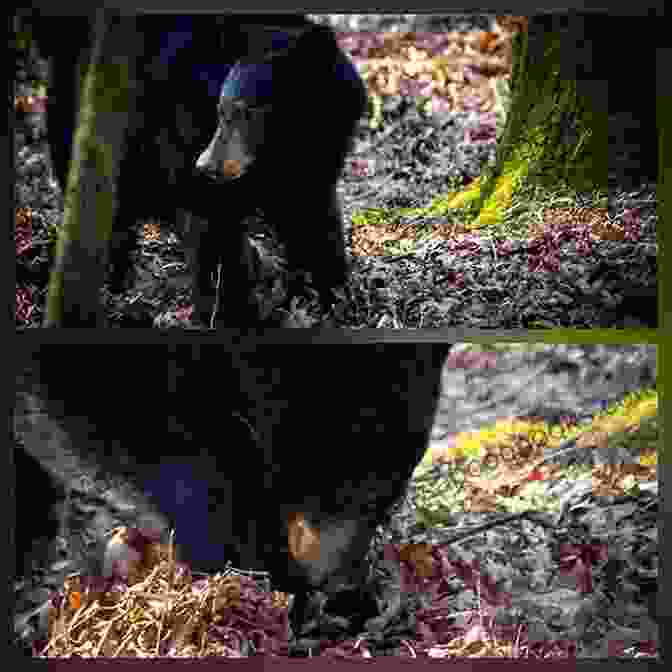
[470,13,660,225]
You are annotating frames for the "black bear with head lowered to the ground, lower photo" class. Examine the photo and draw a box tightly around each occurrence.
[14,340,449,648]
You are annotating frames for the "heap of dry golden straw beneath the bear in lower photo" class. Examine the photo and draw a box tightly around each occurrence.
[38,527,288,658]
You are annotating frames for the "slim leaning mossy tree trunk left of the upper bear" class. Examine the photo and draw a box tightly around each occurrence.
[44,9,137,328]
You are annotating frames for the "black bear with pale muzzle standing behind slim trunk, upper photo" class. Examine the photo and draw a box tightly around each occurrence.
[15,11,367,326]
